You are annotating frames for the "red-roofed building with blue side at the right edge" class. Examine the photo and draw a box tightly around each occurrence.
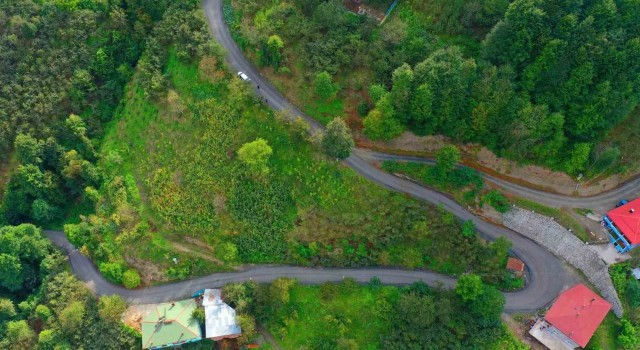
[602,198,640,253]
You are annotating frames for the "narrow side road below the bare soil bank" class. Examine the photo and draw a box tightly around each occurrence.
[357,149,640,213]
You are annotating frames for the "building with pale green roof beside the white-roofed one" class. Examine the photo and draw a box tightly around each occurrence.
[142,299,202,349]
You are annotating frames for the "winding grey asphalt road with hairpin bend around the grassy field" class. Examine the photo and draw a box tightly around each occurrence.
[36,0,579,312]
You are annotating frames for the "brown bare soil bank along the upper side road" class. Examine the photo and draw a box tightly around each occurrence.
[357,131,630,196]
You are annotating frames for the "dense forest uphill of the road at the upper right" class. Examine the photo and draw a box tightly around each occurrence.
[226,0,640,176]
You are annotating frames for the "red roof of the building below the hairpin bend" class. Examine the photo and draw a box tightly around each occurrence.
[544,284,611,348]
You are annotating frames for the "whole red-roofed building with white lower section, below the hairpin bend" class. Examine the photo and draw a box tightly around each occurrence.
[529,284,611,350]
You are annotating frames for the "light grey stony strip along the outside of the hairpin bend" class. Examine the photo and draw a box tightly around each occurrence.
[504,208,623,317]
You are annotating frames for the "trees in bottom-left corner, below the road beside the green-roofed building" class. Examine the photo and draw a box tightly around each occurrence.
[0,225,141,350]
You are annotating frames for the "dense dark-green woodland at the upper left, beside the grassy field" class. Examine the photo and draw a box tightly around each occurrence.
[0,0,178,226]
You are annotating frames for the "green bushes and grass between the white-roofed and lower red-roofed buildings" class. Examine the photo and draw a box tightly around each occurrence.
[224,278,526,349]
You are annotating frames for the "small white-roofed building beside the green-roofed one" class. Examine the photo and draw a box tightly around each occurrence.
[202,289,242,340]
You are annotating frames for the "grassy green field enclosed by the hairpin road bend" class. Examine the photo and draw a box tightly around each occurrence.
[90,47,516,279]
